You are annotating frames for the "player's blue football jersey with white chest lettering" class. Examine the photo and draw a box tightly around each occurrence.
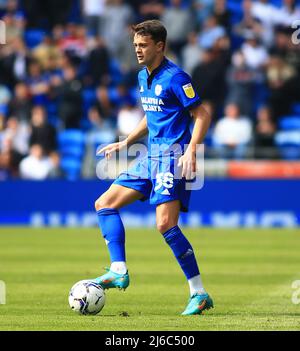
[138,58,201,156]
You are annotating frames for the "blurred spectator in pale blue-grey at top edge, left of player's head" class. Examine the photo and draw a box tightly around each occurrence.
[100,0,134,56]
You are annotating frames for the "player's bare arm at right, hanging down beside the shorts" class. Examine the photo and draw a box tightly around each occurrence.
[178,105,211,179]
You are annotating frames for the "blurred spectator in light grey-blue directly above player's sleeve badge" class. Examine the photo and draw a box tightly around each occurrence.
[182,32,203,75]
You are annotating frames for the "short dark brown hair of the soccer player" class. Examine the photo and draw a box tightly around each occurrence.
[132,20,167,46]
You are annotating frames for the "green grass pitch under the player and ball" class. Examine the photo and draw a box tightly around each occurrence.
[0,228,300,331]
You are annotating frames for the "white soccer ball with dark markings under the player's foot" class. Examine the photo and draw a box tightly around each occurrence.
[69,280,105,315]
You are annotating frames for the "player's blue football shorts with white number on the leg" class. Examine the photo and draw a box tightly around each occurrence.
[114,157,191,212]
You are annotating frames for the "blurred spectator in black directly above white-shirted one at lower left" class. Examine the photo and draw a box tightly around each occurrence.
[29,105,57,155]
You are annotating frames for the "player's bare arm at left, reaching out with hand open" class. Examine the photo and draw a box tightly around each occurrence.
[97,116,148,160]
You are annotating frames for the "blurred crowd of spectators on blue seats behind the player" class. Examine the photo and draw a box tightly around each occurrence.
[0,0,300,180]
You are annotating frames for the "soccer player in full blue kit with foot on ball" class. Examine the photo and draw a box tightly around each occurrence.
[95,20,213,315]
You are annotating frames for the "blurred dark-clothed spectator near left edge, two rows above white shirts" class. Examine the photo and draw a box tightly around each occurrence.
[8,82,32,124]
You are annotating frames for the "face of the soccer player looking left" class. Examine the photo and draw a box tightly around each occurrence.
[133,34,163,66]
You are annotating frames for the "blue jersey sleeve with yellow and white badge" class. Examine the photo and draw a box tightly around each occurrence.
[171,72,202,109]
